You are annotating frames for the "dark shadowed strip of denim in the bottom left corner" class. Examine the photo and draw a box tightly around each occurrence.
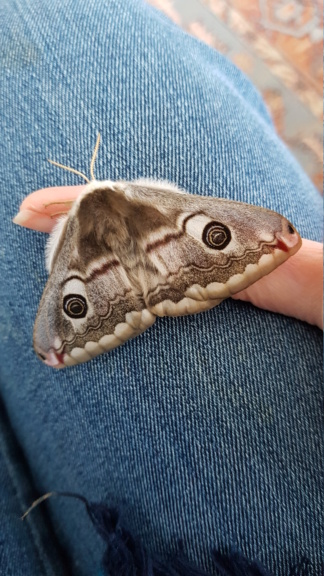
[0,404,68,576]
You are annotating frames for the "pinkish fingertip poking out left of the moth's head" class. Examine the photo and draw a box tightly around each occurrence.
[13,186,84,232]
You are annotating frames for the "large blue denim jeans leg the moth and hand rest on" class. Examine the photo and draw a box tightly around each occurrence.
[0,0,323,576]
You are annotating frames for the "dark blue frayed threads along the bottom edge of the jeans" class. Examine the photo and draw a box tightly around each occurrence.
[21,491,311,576]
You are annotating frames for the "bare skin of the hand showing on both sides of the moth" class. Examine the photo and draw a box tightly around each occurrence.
[13,186,323,330]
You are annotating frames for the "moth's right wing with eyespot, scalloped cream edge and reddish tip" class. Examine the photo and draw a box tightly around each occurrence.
[131,187,301,316]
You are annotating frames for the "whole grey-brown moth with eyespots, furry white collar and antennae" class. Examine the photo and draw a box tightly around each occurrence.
[34,138,301,368]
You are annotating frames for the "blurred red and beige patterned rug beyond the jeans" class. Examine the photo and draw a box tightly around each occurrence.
[147,0,323,193]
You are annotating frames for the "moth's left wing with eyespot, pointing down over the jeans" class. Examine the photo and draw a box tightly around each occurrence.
[34,189,155,368]
